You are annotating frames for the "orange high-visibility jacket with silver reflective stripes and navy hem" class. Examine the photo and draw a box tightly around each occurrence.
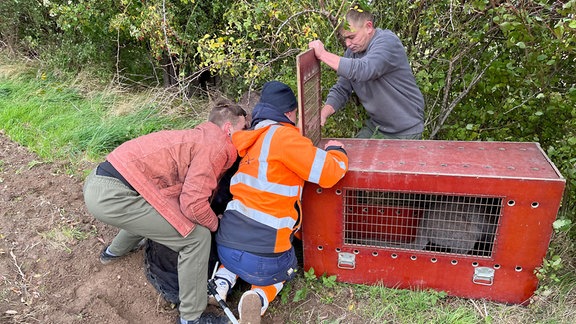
[216,121,348,254]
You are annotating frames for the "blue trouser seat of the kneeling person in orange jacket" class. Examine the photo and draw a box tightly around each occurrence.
[218,245,298,286]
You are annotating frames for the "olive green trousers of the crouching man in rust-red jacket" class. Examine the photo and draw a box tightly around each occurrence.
[84,170,211,320]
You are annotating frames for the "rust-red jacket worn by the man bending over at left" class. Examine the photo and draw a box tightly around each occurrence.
[107,122,238,236]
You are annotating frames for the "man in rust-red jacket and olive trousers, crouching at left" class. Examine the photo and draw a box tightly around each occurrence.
[84,102,246,323]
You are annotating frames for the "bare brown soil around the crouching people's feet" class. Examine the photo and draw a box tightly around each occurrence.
[0,131,366,324]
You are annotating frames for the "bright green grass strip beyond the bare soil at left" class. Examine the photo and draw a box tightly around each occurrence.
[0,66,207,160]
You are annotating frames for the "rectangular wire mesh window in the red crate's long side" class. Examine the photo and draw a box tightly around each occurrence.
[343,189,502,256]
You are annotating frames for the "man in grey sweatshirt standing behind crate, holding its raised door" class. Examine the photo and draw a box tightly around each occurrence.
[309,6,424,139]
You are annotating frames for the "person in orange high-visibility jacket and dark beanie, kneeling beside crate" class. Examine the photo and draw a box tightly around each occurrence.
[212,81,348,324]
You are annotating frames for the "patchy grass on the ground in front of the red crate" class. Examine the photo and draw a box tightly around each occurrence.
[270,272,576,324]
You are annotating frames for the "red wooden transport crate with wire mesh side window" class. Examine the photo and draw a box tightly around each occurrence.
[302,139,565,304]
